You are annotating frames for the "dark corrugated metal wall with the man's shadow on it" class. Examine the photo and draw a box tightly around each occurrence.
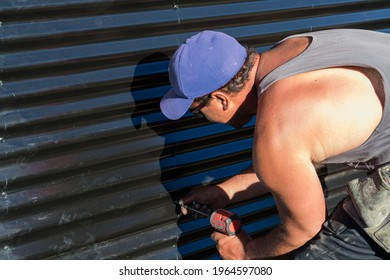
[0,0,390,259]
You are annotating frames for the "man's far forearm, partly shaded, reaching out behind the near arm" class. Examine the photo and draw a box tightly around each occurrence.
[218,167,269,203]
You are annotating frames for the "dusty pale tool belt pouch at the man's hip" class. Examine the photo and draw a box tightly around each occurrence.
[343,165,390,253]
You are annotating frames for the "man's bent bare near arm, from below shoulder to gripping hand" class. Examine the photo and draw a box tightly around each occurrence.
[212,109,326,259]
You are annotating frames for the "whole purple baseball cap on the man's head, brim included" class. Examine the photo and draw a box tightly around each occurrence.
[160,30,247,120]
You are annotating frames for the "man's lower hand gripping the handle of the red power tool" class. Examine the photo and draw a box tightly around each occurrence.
[211,230,252,260]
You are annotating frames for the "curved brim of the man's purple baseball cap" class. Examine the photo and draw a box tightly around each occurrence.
[160,89,194,120]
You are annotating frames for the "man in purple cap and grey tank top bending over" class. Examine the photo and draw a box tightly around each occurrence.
[160,29,390,259]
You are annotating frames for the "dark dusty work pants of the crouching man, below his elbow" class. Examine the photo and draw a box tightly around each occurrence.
[294,198,390,260]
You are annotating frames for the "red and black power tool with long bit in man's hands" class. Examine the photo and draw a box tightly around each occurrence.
[175,201,241,236]
